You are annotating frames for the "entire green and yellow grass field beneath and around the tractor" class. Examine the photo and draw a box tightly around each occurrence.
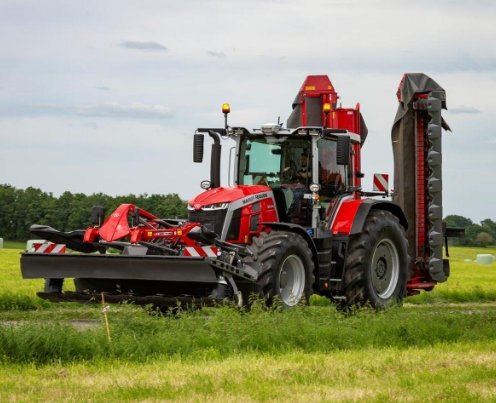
[0,248,496,401]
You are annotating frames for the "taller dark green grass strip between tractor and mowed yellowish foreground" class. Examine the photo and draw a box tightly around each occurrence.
[0,304,496,364]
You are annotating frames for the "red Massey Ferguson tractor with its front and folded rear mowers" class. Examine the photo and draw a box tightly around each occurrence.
[21,74,462,309]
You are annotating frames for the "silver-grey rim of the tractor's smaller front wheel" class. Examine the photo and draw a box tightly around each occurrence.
[279,255,305,306]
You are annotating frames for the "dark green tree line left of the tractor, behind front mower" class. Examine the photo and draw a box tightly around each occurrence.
[0,185,187,241]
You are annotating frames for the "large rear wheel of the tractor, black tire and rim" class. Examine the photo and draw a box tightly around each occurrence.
[340,210,411,310]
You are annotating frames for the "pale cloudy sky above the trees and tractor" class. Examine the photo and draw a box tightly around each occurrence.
[0,0,496,222]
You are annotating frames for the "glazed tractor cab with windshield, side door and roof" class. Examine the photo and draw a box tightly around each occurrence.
[235,128,358,227]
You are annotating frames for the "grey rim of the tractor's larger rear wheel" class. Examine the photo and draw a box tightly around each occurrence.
[371,239,400,299]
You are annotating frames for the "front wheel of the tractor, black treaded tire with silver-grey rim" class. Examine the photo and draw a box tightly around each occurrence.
[242,231,315,308]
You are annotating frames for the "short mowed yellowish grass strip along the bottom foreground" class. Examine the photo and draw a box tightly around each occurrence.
[0,342,496,402]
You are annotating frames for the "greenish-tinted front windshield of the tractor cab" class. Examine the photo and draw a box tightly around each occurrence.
[238,136,312,187]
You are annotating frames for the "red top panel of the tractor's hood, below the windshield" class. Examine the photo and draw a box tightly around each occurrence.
[188,185,271,210]
